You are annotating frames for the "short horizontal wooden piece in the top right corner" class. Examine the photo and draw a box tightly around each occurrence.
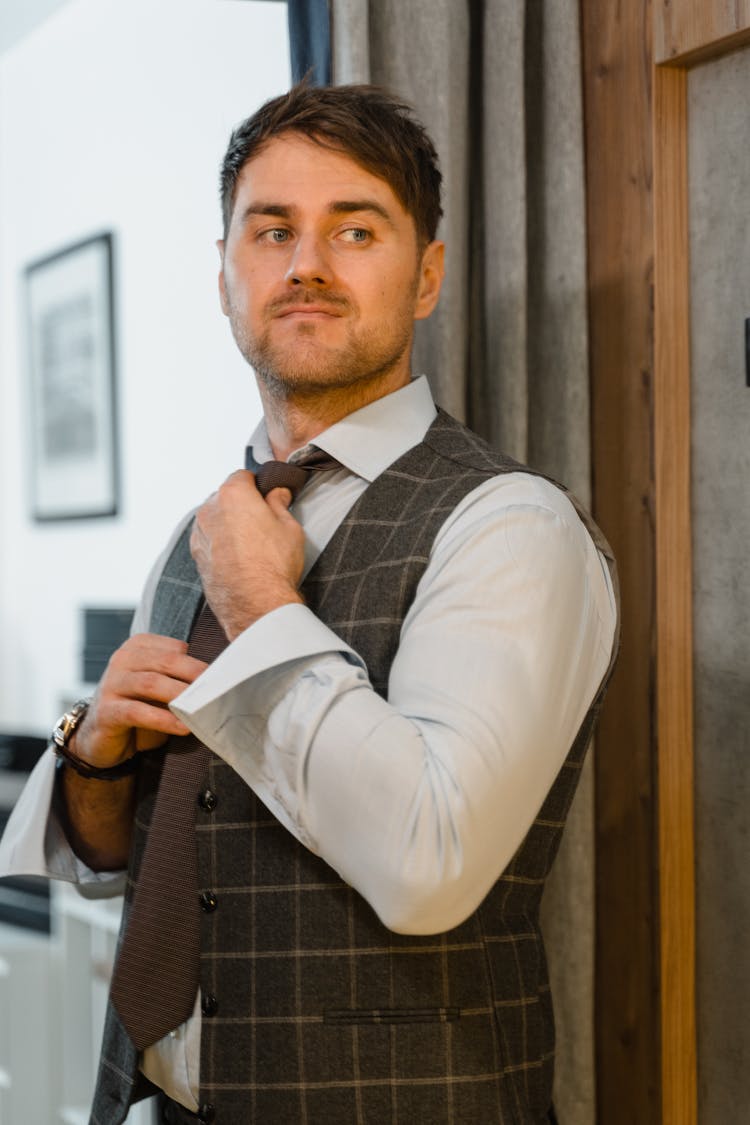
[653,0,750,64]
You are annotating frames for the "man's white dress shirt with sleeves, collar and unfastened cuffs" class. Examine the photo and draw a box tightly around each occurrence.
[0,377,616,1108]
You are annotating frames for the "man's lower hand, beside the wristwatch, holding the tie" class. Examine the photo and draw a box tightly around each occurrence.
[72,633,206,767]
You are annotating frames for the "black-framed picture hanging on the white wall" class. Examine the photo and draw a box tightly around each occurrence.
[25,233,118,520]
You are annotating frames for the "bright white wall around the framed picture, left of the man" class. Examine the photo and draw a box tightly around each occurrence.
[0,0,289,734]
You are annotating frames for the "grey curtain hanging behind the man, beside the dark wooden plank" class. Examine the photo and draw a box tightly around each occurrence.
[332,0,595,1125]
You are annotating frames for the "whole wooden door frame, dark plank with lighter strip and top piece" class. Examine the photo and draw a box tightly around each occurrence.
[580,0,750,1125]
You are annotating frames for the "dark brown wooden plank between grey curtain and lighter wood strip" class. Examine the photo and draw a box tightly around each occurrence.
[581,0,660,1125]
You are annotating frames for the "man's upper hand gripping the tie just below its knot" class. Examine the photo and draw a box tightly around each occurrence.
[190,469,305,640]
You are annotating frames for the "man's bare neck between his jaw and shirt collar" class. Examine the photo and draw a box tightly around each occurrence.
[259,377,408,461]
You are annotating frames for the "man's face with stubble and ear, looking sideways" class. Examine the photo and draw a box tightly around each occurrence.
[219,133,443,397]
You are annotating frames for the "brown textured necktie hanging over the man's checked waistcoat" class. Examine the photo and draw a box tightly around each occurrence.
[111,449,341,1051]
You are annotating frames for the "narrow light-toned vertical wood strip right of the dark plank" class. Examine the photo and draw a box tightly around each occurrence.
[653,68,697,1125]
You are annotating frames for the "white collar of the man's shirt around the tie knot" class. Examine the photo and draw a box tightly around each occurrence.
[246,375,437,480]
